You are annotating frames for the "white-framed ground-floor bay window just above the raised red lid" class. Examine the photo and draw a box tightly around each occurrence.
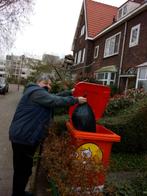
[95,72,116,85]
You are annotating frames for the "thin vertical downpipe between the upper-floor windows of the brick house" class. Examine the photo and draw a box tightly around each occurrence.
[117,22,128,88]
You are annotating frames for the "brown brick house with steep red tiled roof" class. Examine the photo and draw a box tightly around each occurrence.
[72,0,147,90]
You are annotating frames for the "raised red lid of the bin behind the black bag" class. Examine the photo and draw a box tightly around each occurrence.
[69,82,110,120]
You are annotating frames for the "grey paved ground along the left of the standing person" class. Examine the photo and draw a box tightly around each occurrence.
[0,85,22,196]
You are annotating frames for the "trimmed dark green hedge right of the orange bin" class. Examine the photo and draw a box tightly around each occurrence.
[99,97,147,153]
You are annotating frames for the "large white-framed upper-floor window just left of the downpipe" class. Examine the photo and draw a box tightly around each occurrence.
[104,33,120,57]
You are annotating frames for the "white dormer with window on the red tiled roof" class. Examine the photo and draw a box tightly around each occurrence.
[117,0,140,20]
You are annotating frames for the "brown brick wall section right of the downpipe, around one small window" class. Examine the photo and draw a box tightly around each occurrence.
[123,11,147,70]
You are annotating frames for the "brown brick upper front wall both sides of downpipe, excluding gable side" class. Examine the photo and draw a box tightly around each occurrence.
[86,8,147,79]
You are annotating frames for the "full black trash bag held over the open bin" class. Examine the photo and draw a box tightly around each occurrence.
[72,103,96,132]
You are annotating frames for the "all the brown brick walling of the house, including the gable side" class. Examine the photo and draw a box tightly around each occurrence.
[74,1,147,88]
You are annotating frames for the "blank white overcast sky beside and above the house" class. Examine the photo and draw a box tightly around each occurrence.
[9,0,126,57]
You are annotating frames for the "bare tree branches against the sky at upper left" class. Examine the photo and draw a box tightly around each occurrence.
[0,0,34,52]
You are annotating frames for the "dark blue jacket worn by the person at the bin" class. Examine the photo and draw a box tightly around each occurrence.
[9,84,78,145]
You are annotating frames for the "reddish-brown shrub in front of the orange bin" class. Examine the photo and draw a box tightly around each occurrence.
[42,121,105,196]
